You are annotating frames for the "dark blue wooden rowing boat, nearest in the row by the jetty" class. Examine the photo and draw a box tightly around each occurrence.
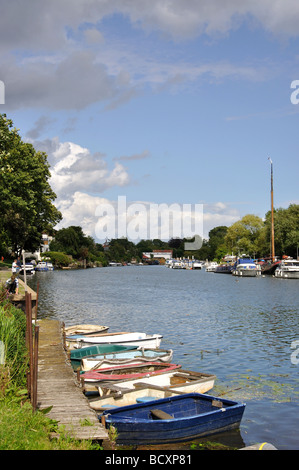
[102,393,245,445]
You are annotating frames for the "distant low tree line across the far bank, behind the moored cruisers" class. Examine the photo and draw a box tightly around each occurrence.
[44,204,299,266]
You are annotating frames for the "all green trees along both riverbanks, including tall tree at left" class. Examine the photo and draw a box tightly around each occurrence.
[0,114,299,265]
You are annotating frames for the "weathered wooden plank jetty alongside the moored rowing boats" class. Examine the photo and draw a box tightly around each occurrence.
[37,319,108,441]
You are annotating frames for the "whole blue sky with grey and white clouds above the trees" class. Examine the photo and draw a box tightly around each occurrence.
[0,0,299,241]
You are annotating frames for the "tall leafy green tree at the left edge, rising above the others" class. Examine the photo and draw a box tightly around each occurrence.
[0,114,62,254]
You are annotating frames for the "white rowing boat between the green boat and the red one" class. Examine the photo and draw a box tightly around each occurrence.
[81,348,173,371]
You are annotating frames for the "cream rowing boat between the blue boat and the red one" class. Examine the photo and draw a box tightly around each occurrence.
[89,369,216,411]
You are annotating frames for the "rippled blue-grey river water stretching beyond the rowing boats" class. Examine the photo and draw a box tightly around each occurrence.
[28,266,299,450]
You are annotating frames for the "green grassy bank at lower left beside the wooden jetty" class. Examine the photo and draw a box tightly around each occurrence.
[0,283,101,450]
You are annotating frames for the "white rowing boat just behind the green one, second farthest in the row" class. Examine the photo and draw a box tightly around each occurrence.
[67,332,163,348]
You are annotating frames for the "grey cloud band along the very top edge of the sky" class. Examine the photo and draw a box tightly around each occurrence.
[0,0,299,50]
